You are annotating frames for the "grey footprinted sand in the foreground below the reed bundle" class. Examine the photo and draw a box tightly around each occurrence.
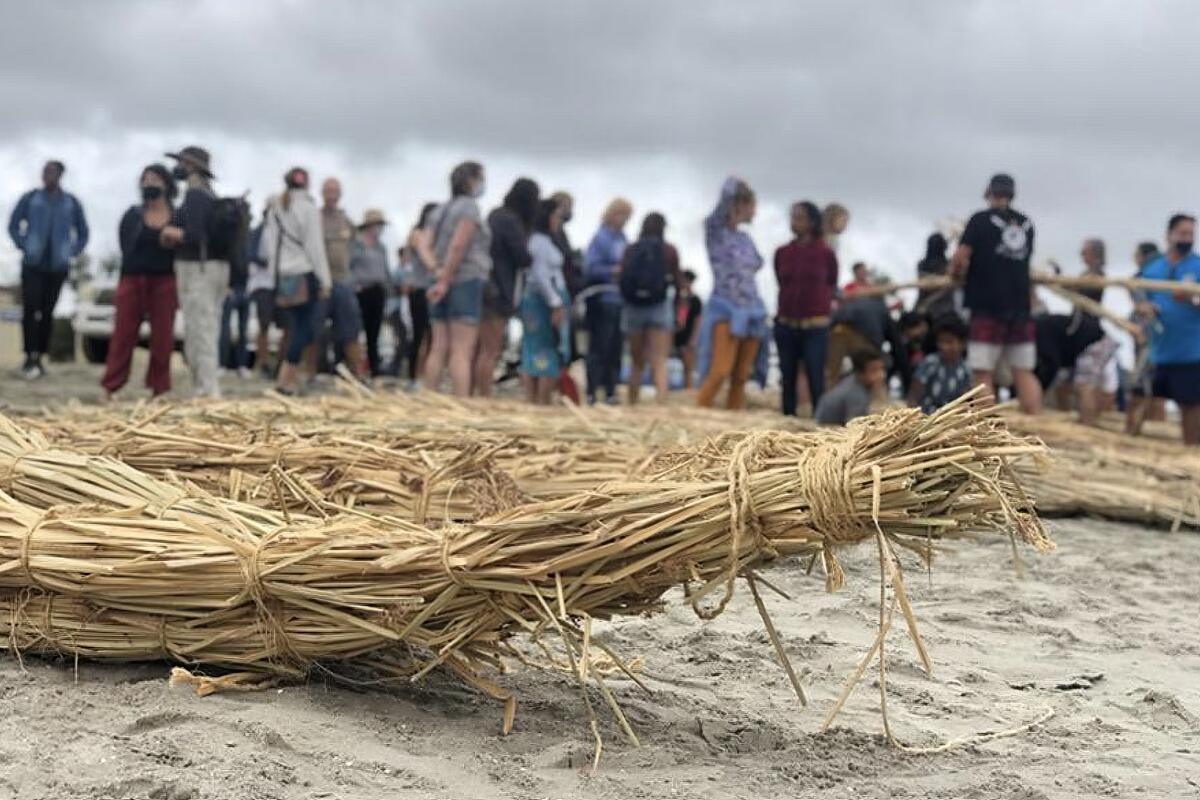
[0,521,1200,800]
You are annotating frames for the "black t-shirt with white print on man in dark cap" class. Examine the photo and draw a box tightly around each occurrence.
[959,209,1033,319]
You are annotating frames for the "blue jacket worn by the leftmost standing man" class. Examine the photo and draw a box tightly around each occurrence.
[8,188,88,272]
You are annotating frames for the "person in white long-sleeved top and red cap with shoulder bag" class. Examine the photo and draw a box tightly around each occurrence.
[259,167,332,395]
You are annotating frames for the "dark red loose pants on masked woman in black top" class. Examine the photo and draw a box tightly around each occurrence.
[100,275,179,395]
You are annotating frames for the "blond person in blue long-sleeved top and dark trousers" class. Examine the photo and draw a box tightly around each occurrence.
[583,197,634,405]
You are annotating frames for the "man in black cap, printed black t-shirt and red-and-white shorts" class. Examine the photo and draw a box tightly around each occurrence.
[950,174,1042,414]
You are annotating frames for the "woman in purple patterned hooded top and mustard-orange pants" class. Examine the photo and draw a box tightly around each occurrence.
[696,178,767,409]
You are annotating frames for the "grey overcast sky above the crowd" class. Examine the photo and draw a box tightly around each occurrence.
[0,0,1200,319]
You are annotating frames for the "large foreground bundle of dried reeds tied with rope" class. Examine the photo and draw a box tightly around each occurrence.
[0,398,1050,734]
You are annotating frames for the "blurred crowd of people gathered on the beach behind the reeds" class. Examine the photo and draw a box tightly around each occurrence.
[8,146,1200,444]
